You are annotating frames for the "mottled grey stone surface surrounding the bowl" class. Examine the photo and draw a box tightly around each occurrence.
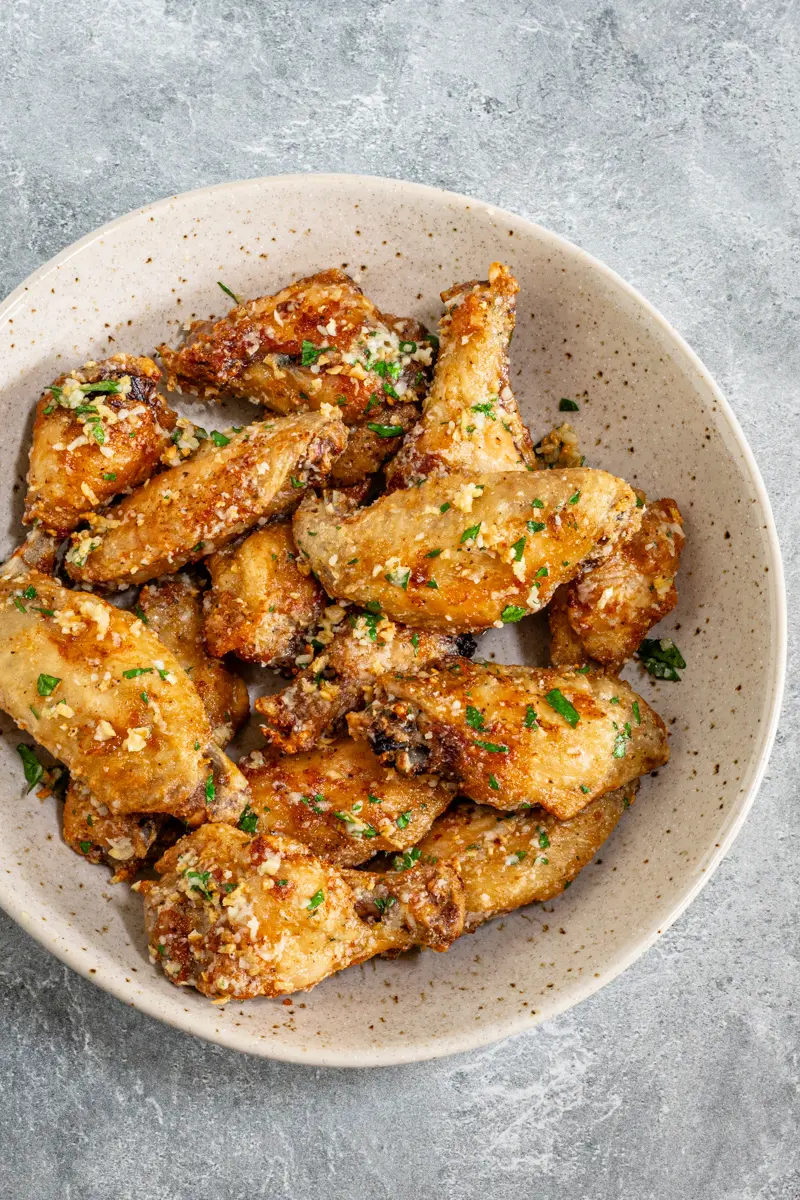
[0,0,800,1200]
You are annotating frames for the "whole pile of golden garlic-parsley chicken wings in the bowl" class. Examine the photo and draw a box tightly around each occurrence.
[0,263,684,1003]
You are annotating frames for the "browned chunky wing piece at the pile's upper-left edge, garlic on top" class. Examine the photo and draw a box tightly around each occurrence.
[23,354,176,535]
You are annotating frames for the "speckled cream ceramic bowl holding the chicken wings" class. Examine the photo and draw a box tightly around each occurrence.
[0,175,786,1066]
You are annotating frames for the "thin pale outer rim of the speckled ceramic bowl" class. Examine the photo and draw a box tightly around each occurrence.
[0,172,788,1068]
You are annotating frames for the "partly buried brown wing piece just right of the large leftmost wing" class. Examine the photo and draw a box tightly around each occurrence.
[139,571,249,749]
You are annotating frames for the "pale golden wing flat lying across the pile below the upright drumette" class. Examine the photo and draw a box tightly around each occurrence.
[294,468,640,632]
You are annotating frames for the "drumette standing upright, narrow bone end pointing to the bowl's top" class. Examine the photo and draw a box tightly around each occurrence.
[386,263,534,490]
